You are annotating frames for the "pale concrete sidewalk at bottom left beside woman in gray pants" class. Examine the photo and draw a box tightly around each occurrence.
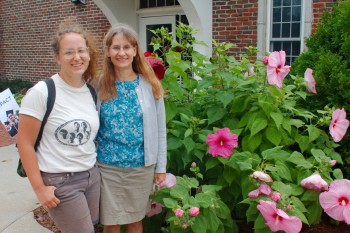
[0,145,51,233]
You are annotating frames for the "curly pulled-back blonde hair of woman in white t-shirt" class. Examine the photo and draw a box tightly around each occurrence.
[51,17,98,83]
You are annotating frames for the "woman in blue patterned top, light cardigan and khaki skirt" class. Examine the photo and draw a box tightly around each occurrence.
[96,24,166,233]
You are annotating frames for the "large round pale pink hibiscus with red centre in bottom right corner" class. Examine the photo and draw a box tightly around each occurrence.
[320,179,350,225]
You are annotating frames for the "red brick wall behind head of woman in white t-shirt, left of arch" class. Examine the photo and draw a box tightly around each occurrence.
[0,0,110,83]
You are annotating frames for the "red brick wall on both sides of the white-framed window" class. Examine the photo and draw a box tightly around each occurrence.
[213,0,337,55]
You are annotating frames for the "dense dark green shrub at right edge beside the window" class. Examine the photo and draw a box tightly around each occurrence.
[292,0,350,177]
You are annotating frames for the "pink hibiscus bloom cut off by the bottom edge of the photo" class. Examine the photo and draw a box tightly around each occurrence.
[257,200,303,233]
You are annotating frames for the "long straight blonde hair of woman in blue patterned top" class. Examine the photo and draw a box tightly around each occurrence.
[99,23,163,101]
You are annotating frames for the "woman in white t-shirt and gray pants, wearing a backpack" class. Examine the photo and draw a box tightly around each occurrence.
[18,19,100,233]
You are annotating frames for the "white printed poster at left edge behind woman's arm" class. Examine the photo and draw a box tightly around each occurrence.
[0,88,19,137]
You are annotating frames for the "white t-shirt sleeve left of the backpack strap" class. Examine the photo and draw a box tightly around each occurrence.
[19,81,48,121]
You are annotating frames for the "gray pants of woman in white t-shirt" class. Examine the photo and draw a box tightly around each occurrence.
[41,166,101,233]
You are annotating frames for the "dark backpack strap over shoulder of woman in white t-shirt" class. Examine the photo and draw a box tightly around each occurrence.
[34,78,56,151]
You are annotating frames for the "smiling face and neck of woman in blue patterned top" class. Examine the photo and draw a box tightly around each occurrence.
[106,34,136,70]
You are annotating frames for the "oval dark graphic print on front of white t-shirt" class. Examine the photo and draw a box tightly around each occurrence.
[55,119,91,146]
